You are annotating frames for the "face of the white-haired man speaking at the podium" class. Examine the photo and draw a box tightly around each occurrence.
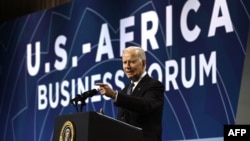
[122,50,146,81]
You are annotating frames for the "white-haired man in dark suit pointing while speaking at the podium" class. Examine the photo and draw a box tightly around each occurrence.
[97,46,164,141]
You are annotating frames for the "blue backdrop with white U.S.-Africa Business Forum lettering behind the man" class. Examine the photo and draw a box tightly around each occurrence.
[0,0,250,141]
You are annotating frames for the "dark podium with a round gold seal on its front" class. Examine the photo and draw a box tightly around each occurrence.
[53,112,143,141]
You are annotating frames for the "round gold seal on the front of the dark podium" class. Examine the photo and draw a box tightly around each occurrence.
[59,121,75,141]
